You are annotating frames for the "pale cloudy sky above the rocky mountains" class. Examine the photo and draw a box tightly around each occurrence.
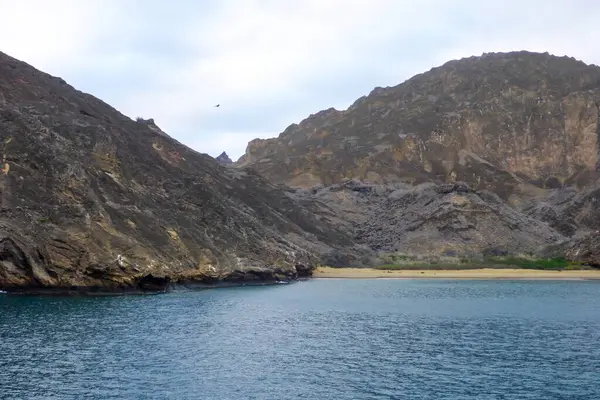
[0,0,600,160]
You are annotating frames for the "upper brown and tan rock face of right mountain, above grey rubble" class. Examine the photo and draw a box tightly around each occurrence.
[236,51,600,200]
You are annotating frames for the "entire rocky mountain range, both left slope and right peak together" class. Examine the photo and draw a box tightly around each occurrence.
[0,52,600,292]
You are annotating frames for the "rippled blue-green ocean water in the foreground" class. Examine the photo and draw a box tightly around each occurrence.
[0,279,600,400]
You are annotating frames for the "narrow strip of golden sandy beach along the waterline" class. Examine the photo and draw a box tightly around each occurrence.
[313,267,600,279]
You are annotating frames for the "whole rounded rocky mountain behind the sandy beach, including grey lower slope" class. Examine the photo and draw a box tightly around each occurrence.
[234,51,600,264]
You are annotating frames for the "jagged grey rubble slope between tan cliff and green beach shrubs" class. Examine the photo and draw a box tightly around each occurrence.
[295,181,566,262]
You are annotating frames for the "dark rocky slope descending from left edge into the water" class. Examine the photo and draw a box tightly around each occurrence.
[0,53,354,291]
